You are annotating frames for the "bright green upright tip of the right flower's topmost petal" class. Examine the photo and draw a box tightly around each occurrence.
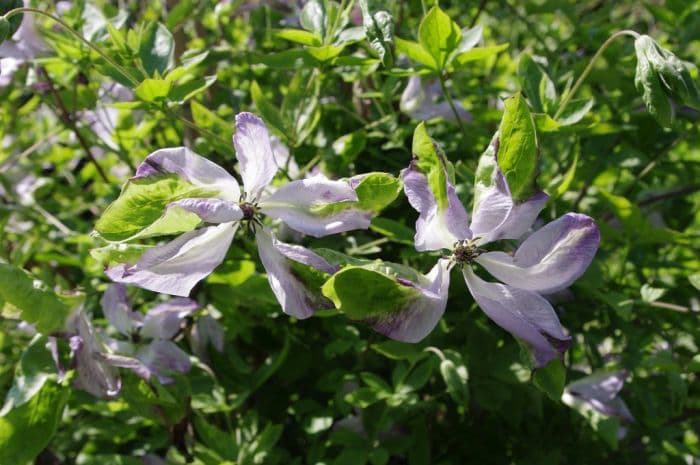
[498,93,539,201]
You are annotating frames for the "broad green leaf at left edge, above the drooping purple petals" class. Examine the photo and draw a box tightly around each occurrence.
[0,260,71,334]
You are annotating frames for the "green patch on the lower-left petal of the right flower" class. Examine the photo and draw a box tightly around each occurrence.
[321,266,421,320]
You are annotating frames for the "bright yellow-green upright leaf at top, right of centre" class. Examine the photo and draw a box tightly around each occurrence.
[418,6,462,71]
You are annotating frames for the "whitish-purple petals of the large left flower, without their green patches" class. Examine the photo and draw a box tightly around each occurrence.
[106,113,372,318]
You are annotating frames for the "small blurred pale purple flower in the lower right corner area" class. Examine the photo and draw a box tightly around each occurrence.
[561,370,634,422]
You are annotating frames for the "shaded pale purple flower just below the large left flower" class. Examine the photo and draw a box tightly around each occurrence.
[101,284,199,384]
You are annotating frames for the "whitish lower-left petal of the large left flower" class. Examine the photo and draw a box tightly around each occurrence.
[105,223,237,297]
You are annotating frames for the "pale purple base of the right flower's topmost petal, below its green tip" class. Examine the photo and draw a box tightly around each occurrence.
[470,166,549,244]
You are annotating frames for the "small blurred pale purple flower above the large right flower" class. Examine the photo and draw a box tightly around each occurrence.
[399,76,472,121]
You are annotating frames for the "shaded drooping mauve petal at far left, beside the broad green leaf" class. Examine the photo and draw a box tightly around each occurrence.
[70,310,121,398]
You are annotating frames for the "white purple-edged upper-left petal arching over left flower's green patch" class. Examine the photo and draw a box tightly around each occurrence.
[132,147,241,202]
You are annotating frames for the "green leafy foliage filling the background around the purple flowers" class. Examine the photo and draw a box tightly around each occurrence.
[0,0,700,465]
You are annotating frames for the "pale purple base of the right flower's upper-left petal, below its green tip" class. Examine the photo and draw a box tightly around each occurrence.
[401,164,472,251]
